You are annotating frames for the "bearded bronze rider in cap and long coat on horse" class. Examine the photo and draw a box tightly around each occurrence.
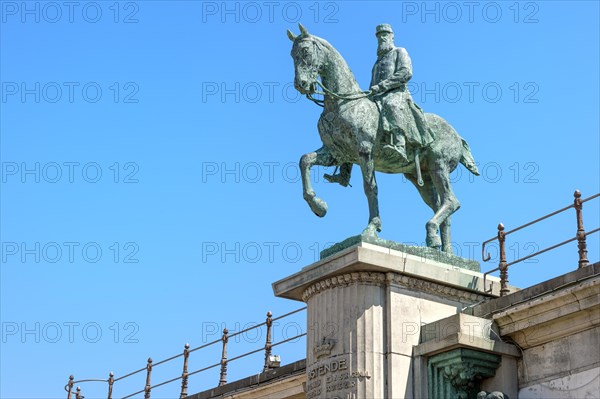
[370,24,433,163]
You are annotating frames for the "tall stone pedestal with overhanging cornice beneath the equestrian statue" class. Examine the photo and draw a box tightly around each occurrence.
[273,241,516,399]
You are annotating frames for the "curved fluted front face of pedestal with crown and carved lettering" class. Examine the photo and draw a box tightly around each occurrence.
[303,272,386,399]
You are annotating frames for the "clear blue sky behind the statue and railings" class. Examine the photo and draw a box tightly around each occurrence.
[0,1,600,399]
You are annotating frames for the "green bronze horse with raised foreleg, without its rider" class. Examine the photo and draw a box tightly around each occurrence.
[287,24,479,253]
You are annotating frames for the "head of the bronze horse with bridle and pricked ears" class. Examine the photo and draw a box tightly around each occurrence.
[287,24,323,94]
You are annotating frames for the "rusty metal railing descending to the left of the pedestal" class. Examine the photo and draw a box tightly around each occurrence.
[65,307,306,399]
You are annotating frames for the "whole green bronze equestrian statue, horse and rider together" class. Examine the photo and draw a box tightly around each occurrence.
[288,24,479,253]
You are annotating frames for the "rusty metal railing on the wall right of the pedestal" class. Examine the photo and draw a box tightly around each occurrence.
[481,190,600,296]
